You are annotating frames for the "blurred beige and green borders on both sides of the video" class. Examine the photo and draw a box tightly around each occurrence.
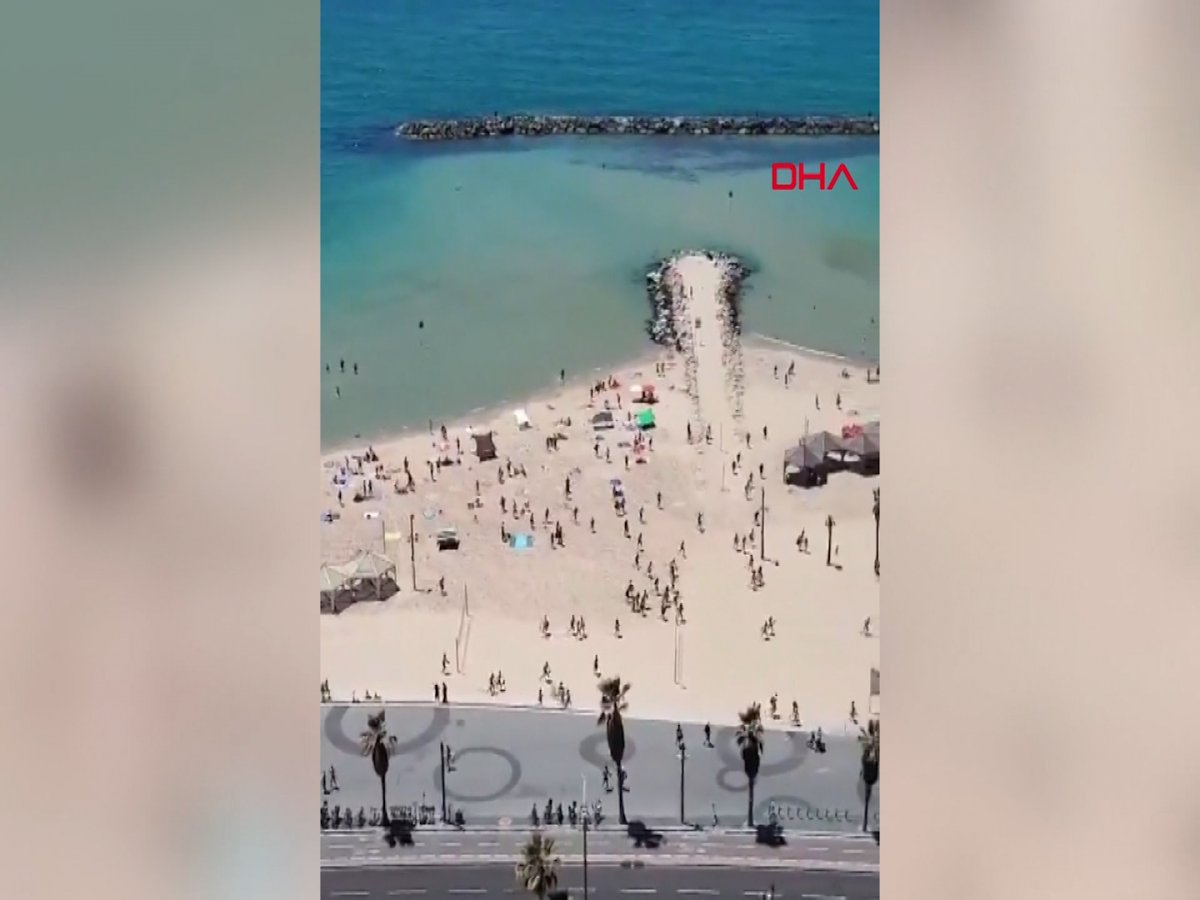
[0,0,1200,900]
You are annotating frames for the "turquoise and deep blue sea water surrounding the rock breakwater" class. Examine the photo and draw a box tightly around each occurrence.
[322,0,878,445]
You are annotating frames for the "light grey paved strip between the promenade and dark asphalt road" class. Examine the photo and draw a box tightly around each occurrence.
[320,828,880,872]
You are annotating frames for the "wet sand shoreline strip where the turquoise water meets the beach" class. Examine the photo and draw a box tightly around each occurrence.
[320,331,880,461]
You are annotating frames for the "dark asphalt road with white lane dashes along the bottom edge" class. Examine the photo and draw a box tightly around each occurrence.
[320,864,880,900]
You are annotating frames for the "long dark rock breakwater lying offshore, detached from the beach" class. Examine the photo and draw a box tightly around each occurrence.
[396,115,880,140]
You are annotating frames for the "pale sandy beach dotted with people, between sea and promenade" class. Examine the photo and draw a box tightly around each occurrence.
[320,254,882,733]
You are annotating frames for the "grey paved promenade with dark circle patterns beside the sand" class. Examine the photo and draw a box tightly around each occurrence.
[324,703,880,832]
